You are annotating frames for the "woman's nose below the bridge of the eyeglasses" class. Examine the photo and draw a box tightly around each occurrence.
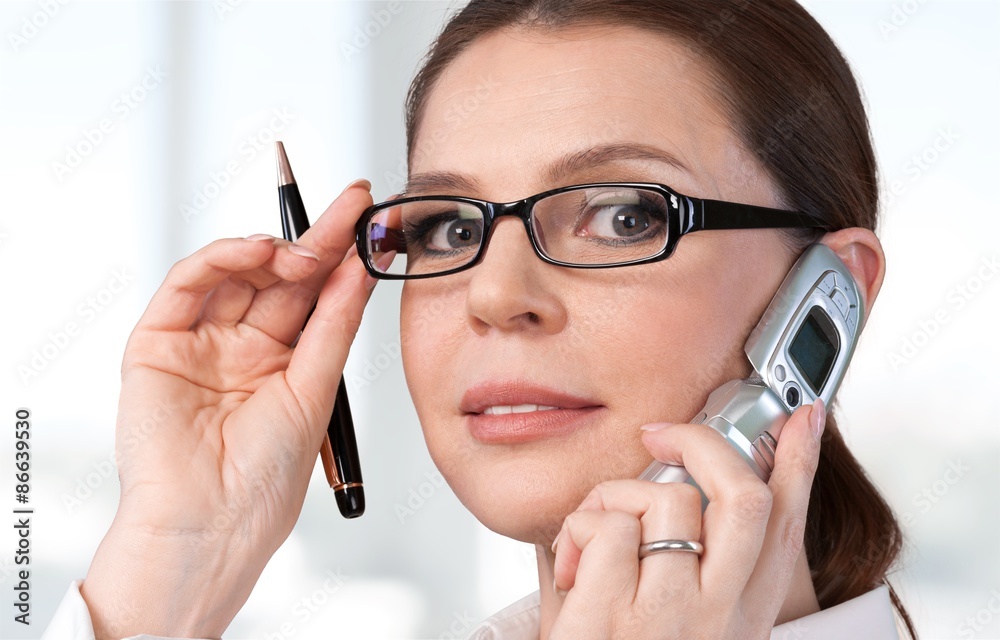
[466,217,566,335]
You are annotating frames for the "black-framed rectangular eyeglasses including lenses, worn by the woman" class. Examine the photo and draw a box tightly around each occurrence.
[356,182,824,280]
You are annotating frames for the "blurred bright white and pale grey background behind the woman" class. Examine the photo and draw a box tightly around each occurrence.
[0,0,1000,639]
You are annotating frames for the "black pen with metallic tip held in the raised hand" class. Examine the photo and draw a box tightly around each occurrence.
[274,142,365,518]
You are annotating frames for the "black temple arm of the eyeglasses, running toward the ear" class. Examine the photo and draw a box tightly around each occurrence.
[678,196,825,235]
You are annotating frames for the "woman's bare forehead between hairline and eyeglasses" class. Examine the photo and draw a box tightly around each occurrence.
[410,26,748,199]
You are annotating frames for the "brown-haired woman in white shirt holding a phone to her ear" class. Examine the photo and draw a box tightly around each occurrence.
[47,0,912,638]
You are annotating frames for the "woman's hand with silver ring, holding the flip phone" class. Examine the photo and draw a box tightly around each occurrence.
[549,402,825,639]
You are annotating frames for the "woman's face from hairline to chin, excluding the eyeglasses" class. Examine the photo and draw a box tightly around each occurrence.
[402,26,794,543]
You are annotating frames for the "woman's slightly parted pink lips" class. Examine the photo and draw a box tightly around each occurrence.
[459,380,604,444]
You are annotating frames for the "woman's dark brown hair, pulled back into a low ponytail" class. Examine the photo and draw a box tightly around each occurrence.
[406,0,916,637]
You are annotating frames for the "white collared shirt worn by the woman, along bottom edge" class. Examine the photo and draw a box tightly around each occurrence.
[42,580,899,640]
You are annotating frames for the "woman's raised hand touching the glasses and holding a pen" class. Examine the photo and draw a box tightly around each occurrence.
[82,181,374,638]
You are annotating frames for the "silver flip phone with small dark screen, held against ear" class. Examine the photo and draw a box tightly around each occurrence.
[639,244,864,486]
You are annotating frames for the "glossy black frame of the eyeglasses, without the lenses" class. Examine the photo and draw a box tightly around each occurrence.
[355,182,827,280]
